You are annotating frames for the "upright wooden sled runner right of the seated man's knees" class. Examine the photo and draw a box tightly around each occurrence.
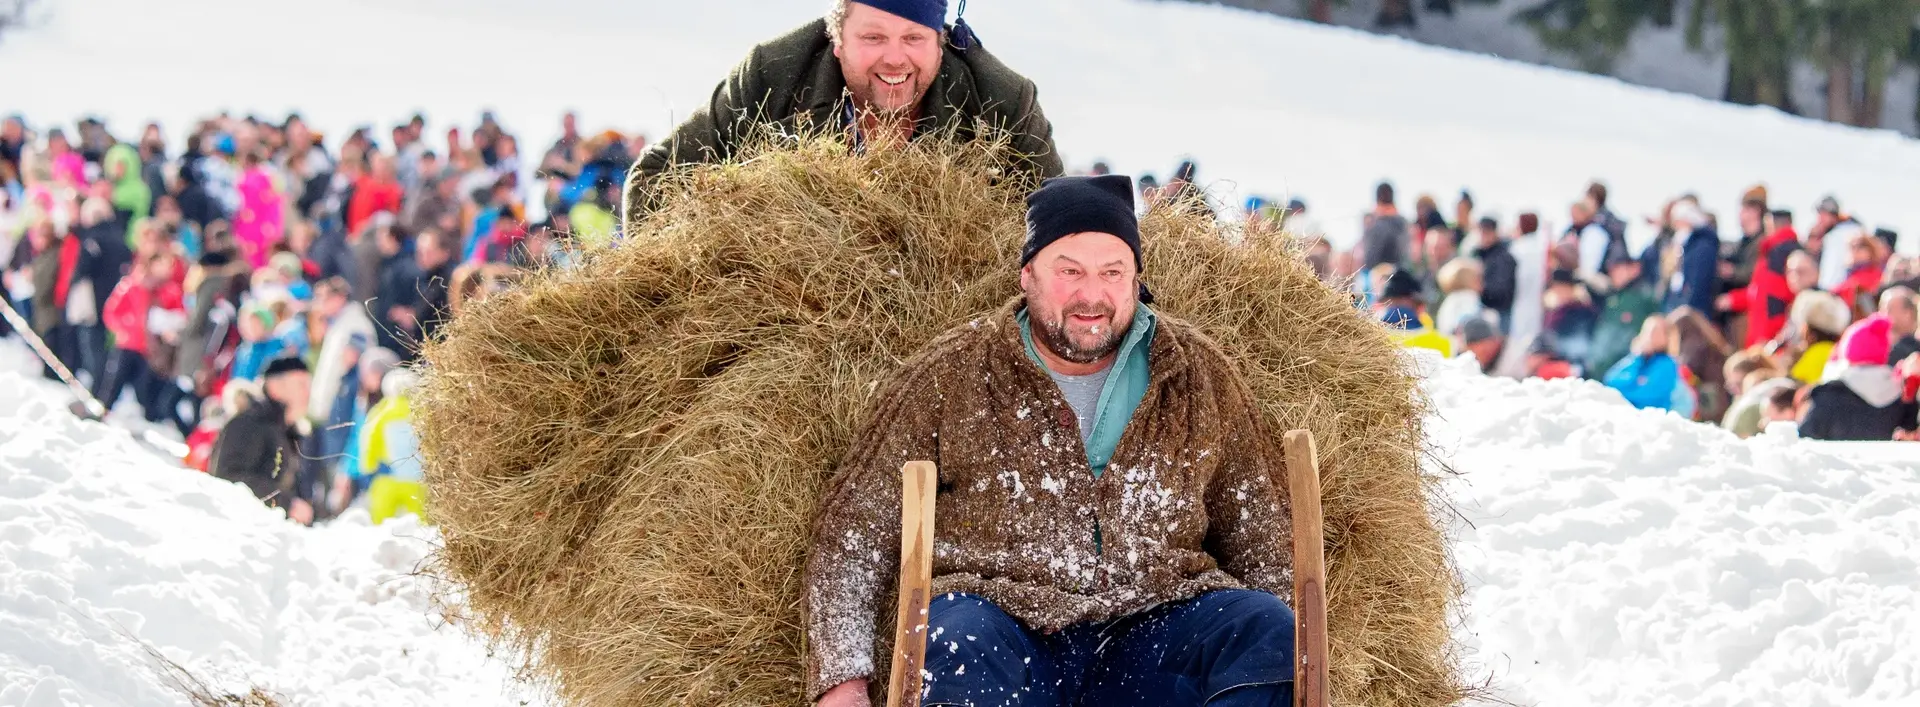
[1286,430,1329,707]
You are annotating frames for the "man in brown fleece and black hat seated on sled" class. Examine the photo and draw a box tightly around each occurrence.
[804,177,1294,707]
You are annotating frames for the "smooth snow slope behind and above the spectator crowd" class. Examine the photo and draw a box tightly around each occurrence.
[0,0,1920,252]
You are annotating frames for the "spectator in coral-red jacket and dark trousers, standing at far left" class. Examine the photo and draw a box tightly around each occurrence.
[94,252,186,416]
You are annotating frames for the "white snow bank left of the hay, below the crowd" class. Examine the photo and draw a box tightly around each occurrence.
[0,371,538,707]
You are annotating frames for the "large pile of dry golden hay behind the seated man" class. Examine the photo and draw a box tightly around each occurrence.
[415,135,1461,707]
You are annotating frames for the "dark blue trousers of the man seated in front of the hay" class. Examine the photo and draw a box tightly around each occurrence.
[920,590,1294,707]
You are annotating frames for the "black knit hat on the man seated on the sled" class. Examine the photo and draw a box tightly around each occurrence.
[1020,175,1144,269]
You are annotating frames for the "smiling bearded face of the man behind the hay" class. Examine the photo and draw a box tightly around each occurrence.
[833,2,941,115]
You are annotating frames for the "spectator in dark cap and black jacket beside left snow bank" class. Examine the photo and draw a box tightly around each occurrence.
[207,357,313,523]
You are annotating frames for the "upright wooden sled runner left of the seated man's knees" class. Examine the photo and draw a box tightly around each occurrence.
[887,461,939,707]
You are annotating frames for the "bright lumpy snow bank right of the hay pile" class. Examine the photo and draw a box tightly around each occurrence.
[1428,355,1920,705]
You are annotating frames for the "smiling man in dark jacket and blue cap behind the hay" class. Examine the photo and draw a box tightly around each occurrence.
[624,0,1062,219]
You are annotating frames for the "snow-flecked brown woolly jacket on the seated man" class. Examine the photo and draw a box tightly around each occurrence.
[804,298,1292,697]
